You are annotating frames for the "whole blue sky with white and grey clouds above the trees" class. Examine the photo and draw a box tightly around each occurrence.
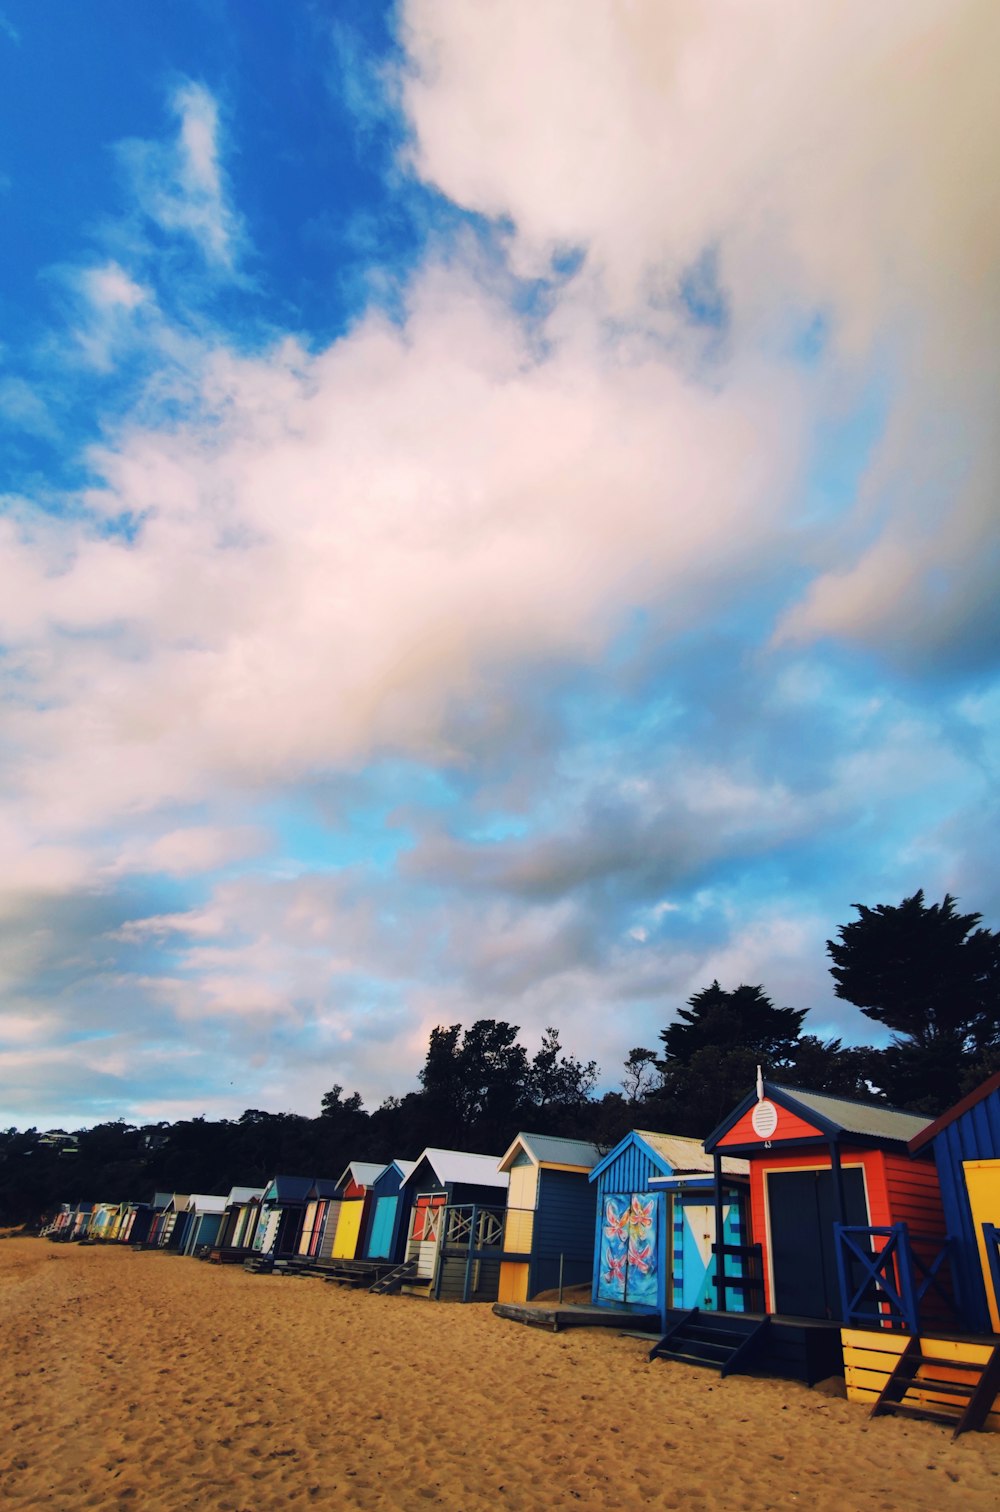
[0,0,1000,1126]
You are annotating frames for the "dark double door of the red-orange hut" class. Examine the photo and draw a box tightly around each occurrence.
[767,1169,868,1318]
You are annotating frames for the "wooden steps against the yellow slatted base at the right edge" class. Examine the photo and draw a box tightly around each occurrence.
[870,1335,1000,1438]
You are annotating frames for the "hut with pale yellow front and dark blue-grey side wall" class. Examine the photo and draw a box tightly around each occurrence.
[498,1132,601,1302]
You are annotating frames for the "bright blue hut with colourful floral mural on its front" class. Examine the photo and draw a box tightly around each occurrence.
[590,1129,749,1320]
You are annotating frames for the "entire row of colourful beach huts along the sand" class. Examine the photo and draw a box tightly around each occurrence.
[44,1074,1000,1433]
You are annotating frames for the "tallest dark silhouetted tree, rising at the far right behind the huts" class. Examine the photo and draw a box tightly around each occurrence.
[826,889,1000,1113]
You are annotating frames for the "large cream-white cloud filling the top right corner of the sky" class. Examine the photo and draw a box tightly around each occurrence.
[402,0,1000,659]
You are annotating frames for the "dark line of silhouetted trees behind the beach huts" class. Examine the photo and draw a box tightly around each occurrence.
[0,892,1000,1223]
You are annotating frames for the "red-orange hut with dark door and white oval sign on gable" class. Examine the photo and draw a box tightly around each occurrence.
[705,1078,944,1321]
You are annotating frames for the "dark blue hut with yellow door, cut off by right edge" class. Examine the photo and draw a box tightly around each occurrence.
[909,1070,1000,1335]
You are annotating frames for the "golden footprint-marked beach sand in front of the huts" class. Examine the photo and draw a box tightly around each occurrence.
[0,1238,1000,1512]
